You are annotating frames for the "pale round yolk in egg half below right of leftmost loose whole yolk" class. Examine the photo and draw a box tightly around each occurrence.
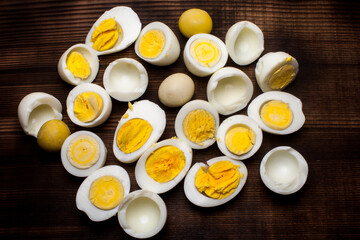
[67,135,100,169]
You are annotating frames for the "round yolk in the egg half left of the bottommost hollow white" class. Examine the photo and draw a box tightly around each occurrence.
[89,176,124,210]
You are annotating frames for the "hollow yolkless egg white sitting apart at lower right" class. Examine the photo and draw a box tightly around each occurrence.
[260,146,309,195]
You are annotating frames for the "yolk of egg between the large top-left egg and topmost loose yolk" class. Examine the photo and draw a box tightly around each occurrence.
[139,29,165,58]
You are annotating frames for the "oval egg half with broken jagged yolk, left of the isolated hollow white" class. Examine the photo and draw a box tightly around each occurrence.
[184,156,248,207]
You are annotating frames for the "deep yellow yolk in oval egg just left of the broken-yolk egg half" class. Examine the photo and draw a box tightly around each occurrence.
[145,146,185,183]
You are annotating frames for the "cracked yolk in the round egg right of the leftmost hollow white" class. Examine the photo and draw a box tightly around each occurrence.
[74,92,103,122]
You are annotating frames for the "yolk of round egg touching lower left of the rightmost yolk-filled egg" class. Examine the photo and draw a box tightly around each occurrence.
[225,124,256,155]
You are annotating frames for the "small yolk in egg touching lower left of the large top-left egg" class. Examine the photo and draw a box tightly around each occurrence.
[66,51,91,80]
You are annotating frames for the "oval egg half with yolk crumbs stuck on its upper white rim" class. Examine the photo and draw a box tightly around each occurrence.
[113,100,166,163]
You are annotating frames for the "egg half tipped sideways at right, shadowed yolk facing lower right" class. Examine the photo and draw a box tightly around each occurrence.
[255,52,299,92]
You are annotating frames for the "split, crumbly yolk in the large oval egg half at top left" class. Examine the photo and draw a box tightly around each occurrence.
[91,18,122,52]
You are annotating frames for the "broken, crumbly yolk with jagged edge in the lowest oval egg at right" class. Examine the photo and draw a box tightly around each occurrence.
[195,161,243,199]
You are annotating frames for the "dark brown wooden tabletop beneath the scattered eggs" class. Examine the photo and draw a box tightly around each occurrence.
[0,0,360,239]
